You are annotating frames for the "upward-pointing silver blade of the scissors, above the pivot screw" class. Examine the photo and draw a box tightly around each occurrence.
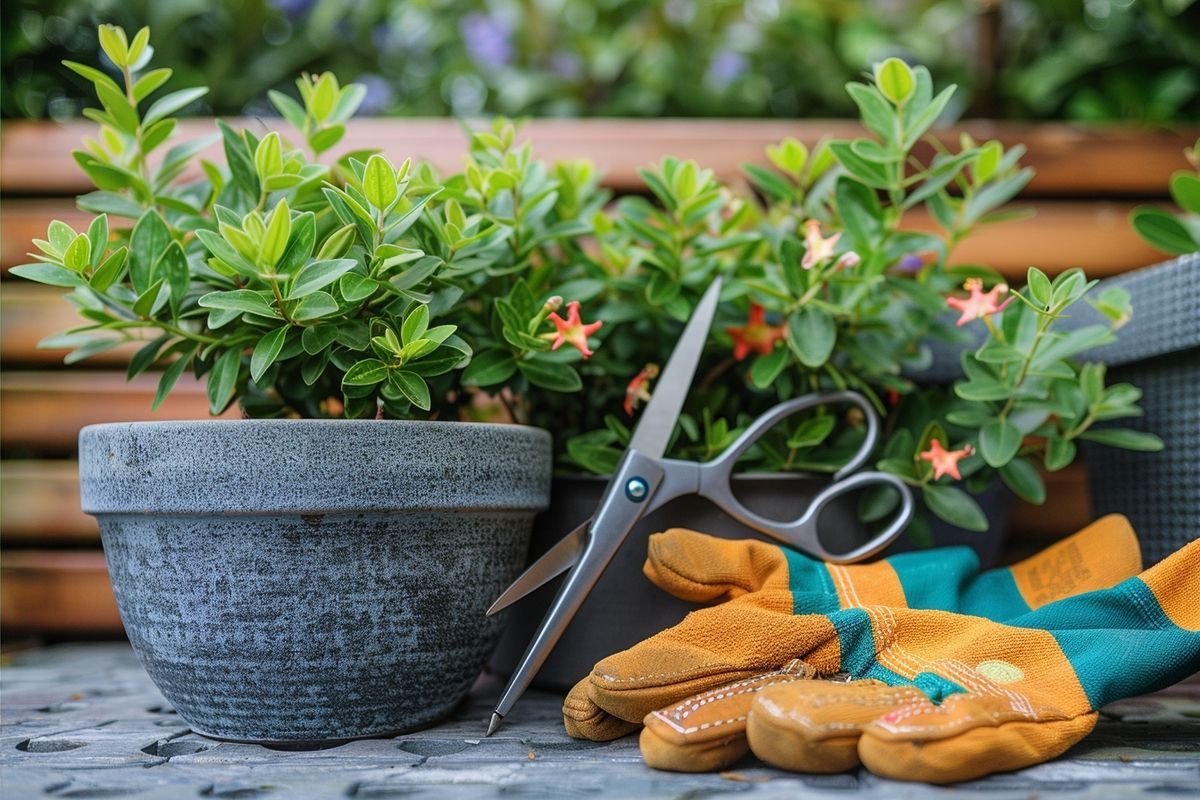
[629,277,721,458]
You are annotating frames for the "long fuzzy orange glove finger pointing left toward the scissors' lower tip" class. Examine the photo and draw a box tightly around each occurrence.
[588,593,838,722]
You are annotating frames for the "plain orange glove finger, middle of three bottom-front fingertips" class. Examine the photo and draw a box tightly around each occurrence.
[746,680,924,772]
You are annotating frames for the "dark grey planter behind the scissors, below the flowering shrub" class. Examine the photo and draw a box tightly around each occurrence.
[491,474,1010,690]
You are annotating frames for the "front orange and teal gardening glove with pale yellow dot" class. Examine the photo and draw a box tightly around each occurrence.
[746,540,1200,783]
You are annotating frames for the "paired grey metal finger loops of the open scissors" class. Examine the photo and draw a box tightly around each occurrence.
[698,391,913,564]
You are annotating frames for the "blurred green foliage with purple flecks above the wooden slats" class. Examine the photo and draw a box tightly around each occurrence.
[0,0,1200,124]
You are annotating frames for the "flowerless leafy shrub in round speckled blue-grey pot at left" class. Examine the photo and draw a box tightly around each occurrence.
[13,25,599,741]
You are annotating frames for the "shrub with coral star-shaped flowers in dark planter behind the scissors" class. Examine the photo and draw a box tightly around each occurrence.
[484,60,1162,685]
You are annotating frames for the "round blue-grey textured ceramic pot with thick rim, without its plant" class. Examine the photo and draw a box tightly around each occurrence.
[79,420,551,742]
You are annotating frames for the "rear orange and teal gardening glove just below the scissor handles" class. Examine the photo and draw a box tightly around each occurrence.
[563,515,1140,752]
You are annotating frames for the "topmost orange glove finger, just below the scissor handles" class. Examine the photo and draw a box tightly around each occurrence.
[642,528,787,602]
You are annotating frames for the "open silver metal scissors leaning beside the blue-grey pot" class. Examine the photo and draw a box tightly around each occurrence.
[487,277,913,735]
